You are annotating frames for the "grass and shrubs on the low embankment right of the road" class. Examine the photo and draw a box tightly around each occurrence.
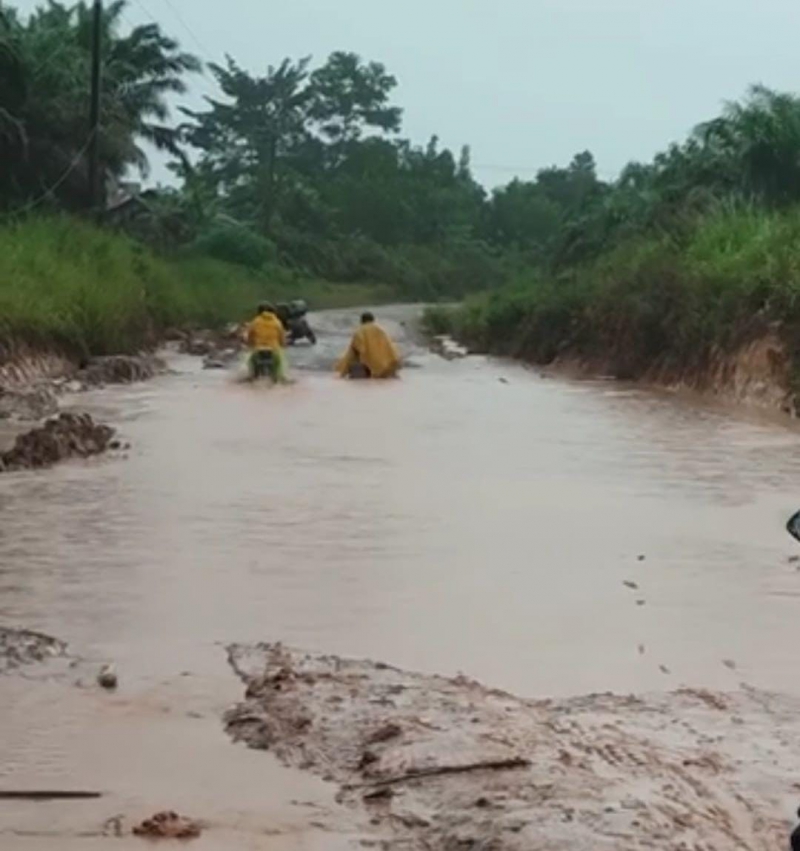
[427,206,800,378]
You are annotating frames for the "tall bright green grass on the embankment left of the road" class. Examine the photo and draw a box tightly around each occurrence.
[0,217,387,356]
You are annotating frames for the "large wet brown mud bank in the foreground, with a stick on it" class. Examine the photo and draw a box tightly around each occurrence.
[226,644,800,851]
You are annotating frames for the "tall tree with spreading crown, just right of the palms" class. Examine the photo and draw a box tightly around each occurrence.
[184,53,400,233]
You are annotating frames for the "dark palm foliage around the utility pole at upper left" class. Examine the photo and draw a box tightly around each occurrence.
[0,0,201,207]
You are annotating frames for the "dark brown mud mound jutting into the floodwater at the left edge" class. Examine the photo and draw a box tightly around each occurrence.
[0,413,114,472]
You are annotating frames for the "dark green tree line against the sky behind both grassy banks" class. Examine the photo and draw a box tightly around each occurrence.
[0,0,800,298]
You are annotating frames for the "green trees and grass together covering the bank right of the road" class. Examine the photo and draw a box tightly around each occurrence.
[428,87,800,386]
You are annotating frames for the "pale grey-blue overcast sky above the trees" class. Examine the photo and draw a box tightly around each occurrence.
[12,0,800,186]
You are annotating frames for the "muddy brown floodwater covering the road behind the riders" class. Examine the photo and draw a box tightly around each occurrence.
[0,308,800,851]
